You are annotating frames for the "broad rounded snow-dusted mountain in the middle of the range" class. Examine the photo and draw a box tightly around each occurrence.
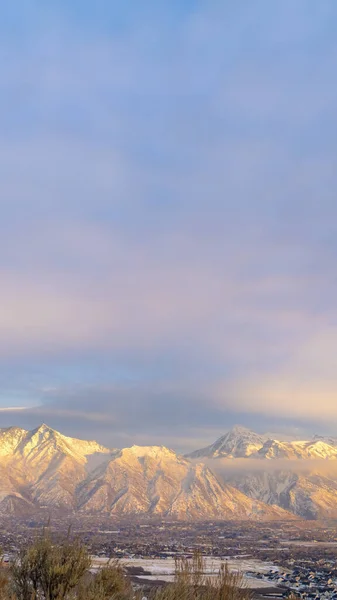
[78,446,289,520]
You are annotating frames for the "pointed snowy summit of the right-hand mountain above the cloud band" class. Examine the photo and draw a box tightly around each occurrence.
[187,425,266,458]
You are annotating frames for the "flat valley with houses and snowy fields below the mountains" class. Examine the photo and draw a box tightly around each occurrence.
[0,512,337,598]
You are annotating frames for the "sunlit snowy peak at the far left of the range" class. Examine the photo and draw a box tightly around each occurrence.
[0,424,111,510]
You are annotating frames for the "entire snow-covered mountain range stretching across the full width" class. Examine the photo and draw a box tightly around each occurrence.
[0,424,337,520]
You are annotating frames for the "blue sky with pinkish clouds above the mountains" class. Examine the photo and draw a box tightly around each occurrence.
[0,0,337,451]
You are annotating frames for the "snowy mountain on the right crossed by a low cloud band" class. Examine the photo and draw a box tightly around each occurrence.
[191,427,337,519]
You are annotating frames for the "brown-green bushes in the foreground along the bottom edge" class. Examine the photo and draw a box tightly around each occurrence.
[0,534,250,600]
